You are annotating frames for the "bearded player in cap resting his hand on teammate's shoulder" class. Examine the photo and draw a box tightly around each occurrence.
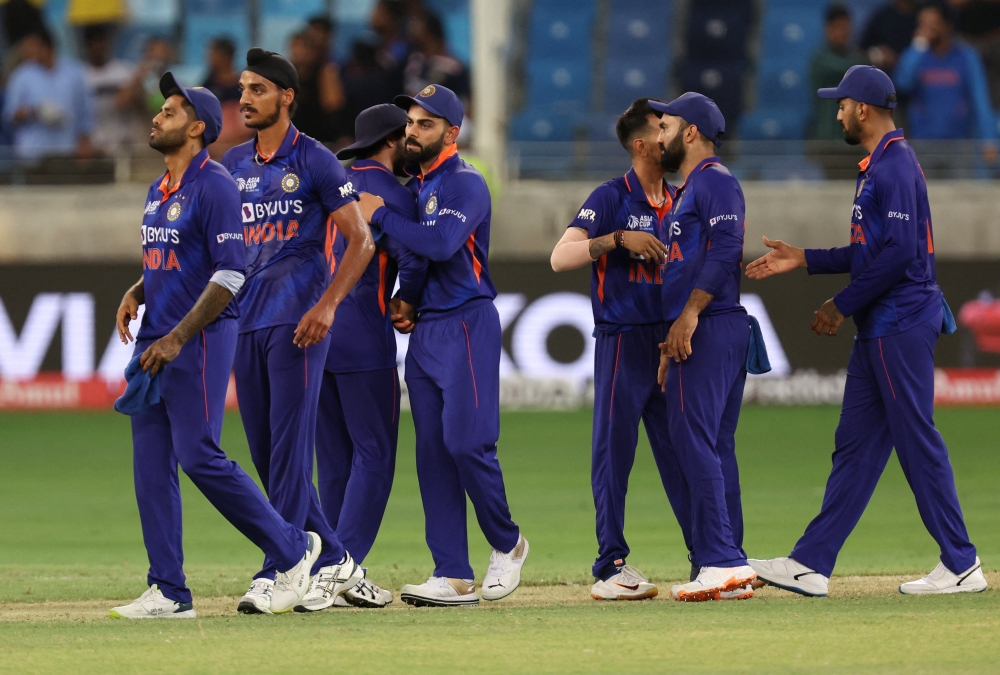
[361,84,528,606]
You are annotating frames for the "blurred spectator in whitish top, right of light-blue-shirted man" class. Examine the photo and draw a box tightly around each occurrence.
[83,24,148,156]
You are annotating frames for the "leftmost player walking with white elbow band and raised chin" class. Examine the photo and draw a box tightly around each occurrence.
[111,72,321,619]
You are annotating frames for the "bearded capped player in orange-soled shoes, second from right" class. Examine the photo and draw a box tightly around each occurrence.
[650,92,757,602]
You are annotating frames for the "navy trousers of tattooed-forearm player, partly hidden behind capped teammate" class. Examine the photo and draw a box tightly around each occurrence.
[590,323,696,579]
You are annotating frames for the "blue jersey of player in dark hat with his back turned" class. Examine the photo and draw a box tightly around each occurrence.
[326,159,427,373]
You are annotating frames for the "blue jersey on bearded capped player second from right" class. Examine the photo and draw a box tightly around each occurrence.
[663,157,746,321]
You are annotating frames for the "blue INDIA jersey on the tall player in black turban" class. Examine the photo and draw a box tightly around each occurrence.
[222,125,358,333]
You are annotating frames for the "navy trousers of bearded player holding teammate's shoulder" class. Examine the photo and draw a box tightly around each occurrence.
[406,300,519,579]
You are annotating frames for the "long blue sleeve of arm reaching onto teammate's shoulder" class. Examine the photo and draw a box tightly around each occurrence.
[372,173,490,261]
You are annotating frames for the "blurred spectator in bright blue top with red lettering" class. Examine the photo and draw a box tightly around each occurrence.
[893,4,997,164]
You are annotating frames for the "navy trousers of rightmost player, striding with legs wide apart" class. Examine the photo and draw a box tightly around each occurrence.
[790,316,976,576]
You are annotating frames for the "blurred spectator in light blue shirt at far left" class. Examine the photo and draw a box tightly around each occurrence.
[3,27,94,159]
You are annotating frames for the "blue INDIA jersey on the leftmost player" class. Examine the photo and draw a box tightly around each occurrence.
[136,150,246,340]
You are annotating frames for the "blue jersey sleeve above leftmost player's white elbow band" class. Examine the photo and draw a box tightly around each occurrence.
[199,174,246,273]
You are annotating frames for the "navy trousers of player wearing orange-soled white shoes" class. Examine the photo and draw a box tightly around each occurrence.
[666,312,750,567]
